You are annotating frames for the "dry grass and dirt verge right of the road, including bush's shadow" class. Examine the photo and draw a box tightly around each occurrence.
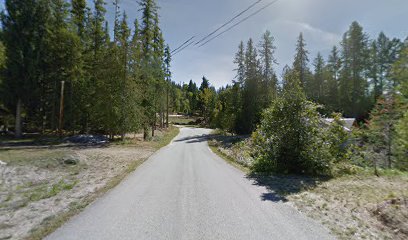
[209,136,408,240]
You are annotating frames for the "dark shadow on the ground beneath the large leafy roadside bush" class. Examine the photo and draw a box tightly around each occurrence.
[247,173,329,202]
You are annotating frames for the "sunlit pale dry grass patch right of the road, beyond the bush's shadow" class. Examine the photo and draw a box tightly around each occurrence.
[287,175,408,239]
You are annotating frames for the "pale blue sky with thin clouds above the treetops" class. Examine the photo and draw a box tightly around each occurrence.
[1,0,408,87]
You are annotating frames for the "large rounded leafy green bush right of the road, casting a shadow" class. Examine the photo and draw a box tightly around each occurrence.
[252,78,343,175]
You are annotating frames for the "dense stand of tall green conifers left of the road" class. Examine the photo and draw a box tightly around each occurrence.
[0,0,190,140]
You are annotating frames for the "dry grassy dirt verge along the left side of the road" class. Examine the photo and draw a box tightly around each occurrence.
[0,127,179,239]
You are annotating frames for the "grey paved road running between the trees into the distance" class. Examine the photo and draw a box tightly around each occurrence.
[46,128,333,240]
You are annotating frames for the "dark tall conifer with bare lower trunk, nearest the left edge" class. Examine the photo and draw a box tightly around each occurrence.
[1,0,49,137]
